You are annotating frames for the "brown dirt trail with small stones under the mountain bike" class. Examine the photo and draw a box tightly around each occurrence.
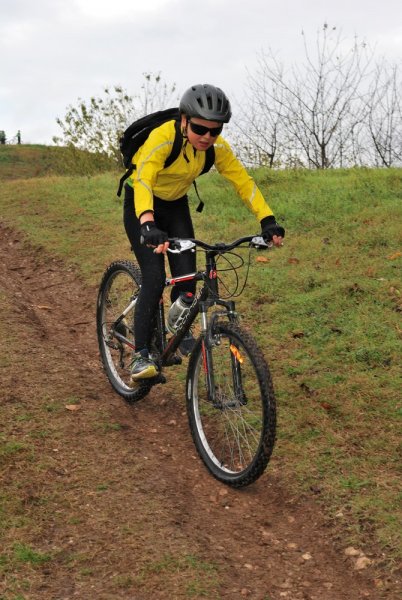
[0,226,390,600]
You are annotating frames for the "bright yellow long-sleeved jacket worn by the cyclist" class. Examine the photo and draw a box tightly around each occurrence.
[128,121,272,221]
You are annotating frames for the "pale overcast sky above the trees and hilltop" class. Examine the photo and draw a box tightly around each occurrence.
[0,0,402,144]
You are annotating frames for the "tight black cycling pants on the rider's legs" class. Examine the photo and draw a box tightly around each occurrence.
[124,184,196,350]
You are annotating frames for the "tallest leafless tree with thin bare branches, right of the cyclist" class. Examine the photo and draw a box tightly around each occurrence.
[239,24,372,169]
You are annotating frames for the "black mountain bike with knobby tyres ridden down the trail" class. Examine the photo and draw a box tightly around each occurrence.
[97,236,276,487]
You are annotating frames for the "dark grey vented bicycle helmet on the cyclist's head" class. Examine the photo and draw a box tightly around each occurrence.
[179,83,232,123]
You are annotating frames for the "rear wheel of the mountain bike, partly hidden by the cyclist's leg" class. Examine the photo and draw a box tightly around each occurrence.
[96,260,152,403]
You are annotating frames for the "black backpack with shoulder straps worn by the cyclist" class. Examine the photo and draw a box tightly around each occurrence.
[117,108,215,212]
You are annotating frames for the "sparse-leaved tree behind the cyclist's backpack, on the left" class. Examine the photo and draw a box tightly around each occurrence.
[53,73,177,162]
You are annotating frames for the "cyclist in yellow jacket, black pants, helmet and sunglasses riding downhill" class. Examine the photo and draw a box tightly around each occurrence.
[124,84,285,381]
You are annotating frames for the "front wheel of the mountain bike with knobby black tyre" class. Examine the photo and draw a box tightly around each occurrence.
[186,323,276,487]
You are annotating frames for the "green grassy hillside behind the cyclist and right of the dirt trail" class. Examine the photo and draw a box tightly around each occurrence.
[0,149,402,568]
